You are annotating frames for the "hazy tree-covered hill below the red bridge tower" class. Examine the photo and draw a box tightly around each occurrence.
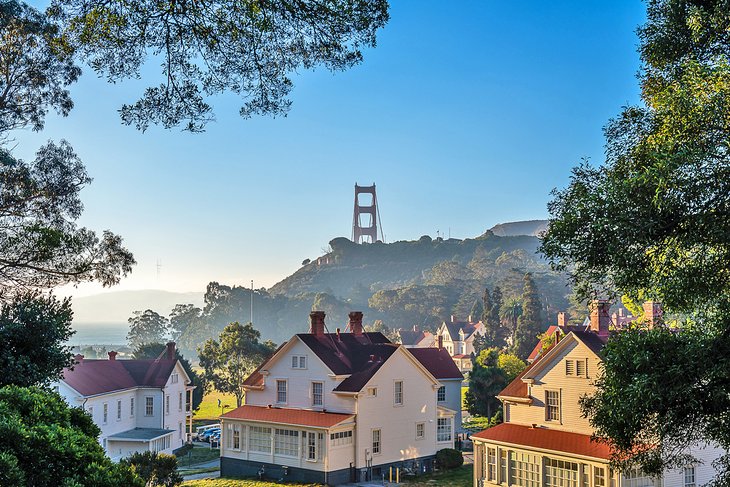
[172,231,570,358]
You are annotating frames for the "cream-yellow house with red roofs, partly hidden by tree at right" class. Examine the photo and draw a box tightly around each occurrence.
[472,301,723,487]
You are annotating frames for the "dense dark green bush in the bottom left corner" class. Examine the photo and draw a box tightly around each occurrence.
[0,386,143,487]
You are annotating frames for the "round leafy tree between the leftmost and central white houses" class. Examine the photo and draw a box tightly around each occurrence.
[198,322,274,407]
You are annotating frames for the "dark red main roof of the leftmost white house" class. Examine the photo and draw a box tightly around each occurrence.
[61,358,177,396]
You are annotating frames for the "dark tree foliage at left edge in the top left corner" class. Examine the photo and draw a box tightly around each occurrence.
[0,1,81,134]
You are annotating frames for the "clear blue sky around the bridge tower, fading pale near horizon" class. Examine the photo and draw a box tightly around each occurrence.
[15,0,645,295]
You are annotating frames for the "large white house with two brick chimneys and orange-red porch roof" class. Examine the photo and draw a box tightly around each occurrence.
[221,311,461,485]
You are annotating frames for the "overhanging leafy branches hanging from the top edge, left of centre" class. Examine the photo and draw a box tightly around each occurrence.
[49,0,388,131]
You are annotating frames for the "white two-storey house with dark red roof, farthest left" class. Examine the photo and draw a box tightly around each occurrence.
[57,342,194,461]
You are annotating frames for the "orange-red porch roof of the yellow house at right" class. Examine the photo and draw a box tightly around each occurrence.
[472,423,611,460]
